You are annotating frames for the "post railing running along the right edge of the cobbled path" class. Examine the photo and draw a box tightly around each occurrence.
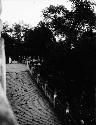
[27,61,78,125]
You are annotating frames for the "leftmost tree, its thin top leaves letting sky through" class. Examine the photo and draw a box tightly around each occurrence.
[2,23,28,59]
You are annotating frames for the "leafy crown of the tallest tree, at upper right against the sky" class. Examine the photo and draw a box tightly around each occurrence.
[43,0,96,50]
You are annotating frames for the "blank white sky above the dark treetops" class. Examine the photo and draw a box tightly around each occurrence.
[1,0,71,26]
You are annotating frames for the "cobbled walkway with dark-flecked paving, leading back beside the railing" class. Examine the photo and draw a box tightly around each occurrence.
[6,64,62,125]
